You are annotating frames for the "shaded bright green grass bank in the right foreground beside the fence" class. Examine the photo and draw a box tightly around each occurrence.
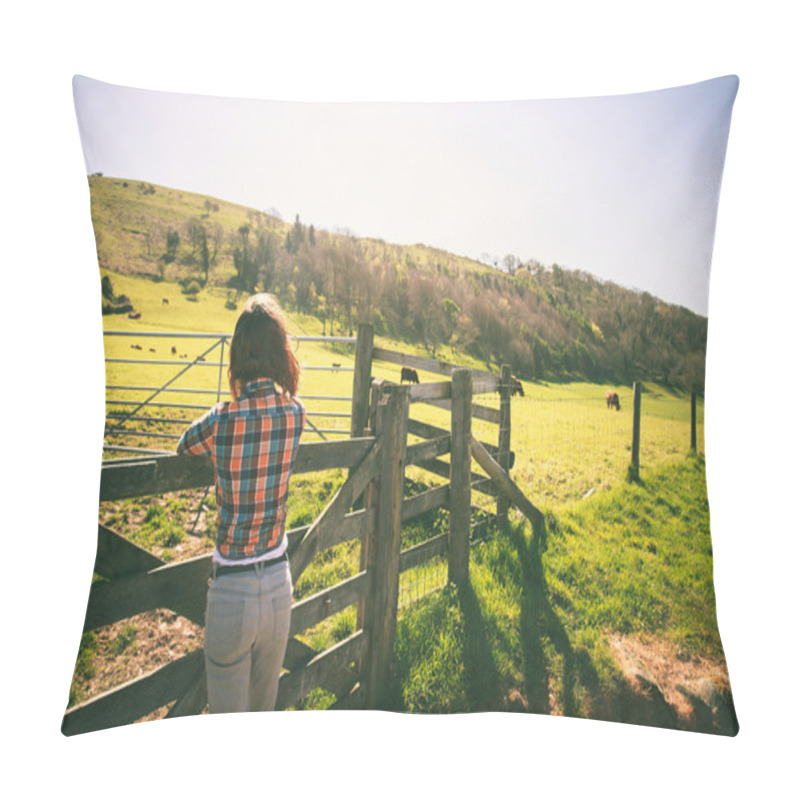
[394,450,727,719]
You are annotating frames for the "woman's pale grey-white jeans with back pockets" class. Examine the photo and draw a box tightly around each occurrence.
[203,561,292,714]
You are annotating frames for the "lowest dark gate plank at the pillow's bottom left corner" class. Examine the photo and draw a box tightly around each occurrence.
[61,650,203,736]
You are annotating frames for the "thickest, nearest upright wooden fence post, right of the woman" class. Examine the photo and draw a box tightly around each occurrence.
[361,385,409,708]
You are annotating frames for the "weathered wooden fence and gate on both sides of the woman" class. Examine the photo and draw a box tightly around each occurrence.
[62,346,538,735]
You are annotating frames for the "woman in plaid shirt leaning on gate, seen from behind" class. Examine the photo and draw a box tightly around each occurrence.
[178,294,305,714]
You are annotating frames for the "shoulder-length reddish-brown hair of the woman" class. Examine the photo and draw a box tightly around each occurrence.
[228,294,300,398]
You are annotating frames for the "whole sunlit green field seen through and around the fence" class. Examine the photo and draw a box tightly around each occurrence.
[76,273,726,716]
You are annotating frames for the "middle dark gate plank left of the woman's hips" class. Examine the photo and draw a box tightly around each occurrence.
[83,554,211,631]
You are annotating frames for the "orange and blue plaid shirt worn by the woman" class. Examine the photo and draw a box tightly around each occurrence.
[178,378,306,561]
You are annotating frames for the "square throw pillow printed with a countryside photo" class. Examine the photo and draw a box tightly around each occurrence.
[62,76,738,735]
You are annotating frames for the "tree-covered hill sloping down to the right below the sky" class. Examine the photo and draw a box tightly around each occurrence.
[90,178,707,391]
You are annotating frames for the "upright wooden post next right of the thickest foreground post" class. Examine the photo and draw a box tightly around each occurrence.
[447,368,472,586]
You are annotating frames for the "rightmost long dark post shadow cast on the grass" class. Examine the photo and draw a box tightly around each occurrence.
[509,522,599,716]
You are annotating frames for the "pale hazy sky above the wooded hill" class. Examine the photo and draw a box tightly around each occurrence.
[73,76,738,316]
